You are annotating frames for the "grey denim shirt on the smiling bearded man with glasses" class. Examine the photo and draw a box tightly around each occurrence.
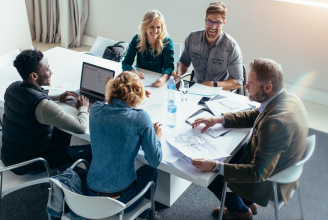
[180,29,244,85]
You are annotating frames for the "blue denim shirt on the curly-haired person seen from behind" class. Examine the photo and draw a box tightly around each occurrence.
[87,99,162,193]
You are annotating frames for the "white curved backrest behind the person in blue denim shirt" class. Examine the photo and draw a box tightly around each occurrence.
[50,178,126,219]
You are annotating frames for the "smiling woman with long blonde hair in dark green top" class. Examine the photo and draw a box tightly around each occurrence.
[122,10,174,87]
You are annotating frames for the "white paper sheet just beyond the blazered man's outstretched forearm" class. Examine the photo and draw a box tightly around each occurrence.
[205,98,250,116]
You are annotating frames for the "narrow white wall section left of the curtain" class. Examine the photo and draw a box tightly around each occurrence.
[0,0,32,56]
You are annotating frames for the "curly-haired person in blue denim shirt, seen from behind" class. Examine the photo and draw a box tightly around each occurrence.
[86,71,162,219]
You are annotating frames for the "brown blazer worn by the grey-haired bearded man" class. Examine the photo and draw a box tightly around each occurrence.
[223,90,308,206]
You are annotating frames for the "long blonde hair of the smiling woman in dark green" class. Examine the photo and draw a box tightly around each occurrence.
[137,10,169,57]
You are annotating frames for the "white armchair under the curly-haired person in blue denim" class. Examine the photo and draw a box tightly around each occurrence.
[50,159,155,220]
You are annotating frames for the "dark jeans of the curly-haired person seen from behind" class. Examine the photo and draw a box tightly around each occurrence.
[85,165,158,218]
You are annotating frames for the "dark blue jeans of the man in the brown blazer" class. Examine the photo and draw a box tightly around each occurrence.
[208,146,253,213]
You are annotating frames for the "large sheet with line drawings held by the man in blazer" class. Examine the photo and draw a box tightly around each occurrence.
[164,126,231,159]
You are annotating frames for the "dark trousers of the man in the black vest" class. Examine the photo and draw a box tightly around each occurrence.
[27,128,92,175]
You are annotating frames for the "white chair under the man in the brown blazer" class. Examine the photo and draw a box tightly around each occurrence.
[218,135,315,220]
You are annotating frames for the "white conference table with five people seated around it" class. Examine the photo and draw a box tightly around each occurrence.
[0,47,255,206]
